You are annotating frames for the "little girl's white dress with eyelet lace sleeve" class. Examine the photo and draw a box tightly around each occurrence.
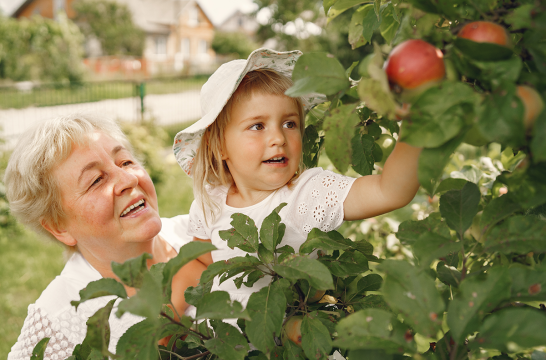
[188,168,356,306]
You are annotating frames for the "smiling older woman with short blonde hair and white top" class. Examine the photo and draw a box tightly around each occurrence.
[5,115,205,360]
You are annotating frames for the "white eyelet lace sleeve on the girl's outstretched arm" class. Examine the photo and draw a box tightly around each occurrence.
[284,169,355,236]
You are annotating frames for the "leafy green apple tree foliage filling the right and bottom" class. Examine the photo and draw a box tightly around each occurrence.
[30,0,546,360]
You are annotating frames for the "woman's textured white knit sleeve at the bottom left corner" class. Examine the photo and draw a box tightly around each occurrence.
[8,304,87,360]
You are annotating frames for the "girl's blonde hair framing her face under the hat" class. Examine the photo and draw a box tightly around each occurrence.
[193,69,305,223]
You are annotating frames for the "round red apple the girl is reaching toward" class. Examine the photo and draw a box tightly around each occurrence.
[385,39,446,102]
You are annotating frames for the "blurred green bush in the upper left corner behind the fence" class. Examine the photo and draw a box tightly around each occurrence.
[0,14,83,83]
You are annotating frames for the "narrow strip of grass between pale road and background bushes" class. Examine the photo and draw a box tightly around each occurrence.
[0,76,206,109]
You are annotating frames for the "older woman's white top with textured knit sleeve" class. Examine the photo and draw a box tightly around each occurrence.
[8,215,195,360]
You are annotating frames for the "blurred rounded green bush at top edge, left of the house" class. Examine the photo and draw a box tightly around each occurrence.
[72,0,145,56]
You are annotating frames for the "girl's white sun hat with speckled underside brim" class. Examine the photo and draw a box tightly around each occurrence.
[173,49,326,176]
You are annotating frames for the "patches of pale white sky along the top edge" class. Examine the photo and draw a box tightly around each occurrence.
[0,0,256,25]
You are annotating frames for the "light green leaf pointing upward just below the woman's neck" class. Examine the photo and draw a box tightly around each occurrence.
[116,272,163,318]
